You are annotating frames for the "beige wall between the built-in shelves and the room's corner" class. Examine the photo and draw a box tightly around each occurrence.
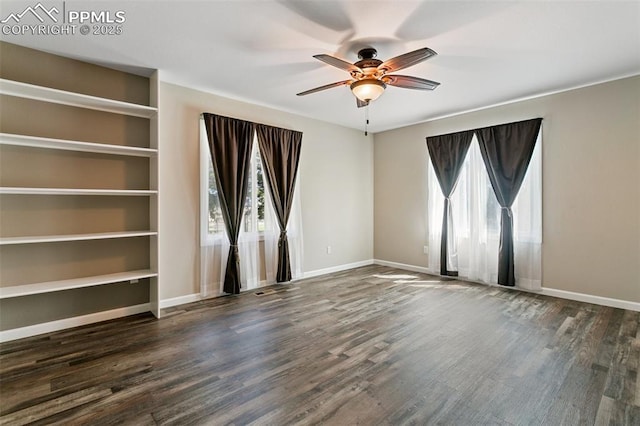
[159,83,373,299]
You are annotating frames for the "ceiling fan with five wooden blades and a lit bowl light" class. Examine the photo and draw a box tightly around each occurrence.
[297,47,440,108]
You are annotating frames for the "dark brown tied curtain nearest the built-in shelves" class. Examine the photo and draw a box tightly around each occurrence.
[203,113,255,294]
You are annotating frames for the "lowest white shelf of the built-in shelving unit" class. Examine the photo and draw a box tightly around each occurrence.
[0,270,158,299]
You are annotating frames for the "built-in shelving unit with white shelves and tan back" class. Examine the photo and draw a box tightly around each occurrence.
[0,42,160,340]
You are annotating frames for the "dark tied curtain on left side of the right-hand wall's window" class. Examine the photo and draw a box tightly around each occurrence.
[427,130,473,276]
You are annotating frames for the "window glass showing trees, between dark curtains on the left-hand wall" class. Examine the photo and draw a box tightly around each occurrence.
[204,136,265,235]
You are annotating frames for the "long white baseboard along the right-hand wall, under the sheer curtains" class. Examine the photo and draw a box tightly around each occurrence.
[374,259,640,312]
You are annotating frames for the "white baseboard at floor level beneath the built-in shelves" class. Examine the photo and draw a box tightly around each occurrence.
[0,303,151,342]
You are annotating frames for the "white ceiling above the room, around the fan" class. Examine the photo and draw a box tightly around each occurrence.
[0,0,640,132]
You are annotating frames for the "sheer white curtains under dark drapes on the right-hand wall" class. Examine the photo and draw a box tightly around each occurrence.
[427,132,542,290]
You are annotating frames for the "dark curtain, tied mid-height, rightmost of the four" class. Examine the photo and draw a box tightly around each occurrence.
[476,118,542,286]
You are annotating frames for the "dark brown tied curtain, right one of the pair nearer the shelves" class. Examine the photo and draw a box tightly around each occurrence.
[256,124,302,282]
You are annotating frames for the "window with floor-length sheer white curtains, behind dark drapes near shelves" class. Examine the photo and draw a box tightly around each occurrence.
[199,119,303,297]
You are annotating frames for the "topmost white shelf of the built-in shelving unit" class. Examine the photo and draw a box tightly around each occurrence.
[0,79,158,118]
